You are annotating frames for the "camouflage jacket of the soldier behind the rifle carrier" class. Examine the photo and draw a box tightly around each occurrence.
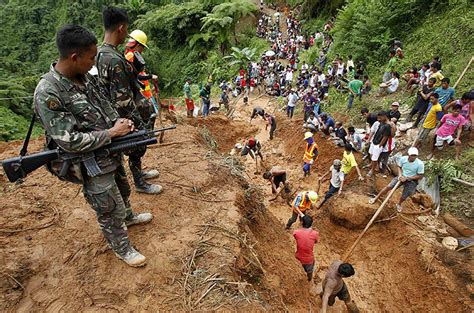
[97,44,151,129]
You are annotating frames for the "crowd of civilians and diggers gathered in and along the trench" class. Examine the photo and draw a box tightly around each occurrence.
[229,4,474,312]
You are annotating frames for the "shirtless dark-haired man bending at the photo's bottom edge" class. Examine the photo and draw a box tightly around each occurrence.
[321,260,359,313]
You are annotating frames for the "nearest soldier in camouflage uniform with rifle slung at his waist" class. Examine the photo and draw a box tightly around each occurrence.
[34,25,153,266]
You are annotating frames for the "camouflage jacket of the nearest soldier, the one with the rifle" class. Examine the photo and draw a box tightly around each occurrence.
[34,64,121,173]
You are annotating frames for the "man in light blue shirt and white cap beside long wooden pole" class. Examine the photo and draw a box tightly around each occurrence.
[369,147,425,212]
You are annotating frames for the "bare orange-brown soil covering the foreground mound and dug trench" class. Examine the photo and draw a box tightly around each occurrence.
[0,91,474,312]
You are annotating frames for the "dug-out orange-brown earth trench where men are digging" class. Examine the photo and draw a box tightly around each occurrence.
[194,96,472,312]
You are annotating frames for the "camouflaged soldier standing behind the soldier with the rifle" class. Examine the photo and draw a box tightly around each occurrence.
[97,7,163,194]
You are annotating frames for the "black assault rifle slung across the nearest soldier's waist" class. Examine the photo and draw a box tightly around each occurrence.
[2,125,176,182]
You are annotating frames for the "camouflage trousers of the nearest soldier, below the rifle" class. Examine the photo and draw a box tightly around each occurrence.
[83,165,133,255]
